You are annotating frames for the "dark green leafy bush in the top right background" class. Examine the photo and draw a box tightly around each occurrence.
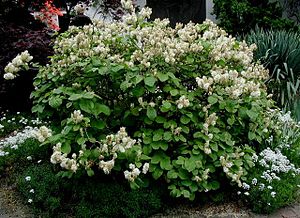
[214,0,296,35]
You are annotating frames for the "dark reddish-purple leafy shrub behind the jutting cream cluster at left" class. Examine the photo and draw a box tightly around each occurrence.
[0,16,53,112]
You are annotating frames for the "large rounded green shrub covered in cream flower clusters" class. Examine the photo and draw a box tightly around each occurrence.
[32,1,292,200]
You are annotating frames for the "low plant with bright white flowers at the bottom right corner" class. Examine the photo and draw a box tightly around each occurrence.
[238,110,300,213]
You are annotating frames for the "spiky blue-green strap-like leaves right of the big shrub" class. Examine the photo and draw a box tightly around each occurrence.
[245,29,300,119]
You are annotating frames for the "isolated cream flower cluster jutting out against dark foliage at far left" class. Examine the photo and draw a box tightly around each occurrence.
[3,50,33,80]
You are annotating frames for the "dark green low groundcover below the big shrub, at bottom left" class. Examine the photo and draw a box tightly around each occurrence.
[18,163,162,218]
